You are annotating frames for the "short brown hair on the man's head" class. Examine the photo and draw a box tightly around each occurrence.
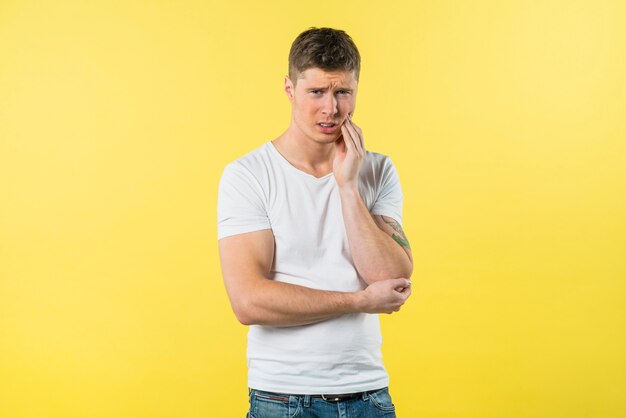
[289,28,361,85]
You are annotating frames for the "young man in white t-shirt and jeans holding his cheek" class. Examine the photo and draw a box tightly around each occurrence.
[218,28,413,418]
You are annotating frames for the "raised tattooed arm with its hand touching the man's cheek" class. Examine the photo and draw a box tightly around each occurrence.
[333,113,413,284]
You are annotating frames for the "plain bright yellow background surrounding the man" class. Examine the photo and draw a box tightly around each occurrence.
[0,0,626,418]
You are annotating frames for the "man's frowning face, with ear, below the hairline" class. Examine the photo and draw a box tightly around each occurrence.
[285,68,358,144]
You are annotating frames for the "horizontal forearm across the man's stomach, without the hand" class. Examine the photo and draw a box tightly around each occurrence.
[233,278,363,327]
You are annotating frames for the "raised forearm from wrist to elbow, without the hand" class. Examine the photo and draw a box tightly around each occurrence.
[340,186,413,284]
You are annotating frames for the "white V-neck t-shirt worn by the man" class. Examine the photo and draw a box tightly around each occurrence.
[218,142,402,394]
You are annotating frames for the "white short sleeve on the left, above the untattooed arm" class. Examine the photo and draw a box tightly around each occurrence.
[217,162,271,239]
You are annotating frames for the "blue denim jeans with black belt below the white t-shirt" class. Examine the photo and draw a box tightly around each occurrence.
[246,388,396,418]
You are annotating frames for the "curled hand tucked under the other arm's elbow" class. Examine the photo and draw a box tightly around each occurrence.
[360,278,411,314]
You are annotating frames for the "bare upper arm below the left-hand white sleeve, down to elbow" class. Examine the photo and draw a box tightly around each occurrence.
[218,229,274,302]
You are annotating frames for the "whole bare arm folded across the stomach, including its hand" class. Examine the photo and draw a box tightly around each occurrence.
[219,229,411,327]
